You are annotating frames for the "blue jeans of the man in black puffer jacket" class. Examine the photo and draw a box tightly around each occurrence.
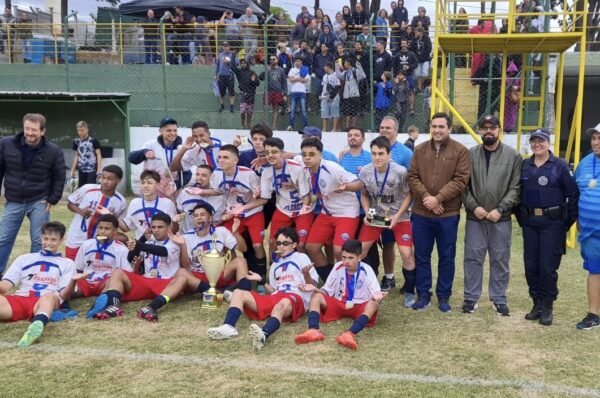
[0,200,49,273]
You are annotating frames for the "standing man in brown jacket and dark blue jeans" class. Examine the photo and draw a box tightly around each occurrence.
[408,113,471,312]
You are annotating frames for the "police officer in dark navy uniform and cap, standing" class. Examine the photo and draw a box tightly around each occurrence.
[518,129,579,326]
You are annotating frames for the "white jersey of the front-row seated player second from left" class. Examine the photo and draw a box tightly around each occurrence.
[75,239,133,283]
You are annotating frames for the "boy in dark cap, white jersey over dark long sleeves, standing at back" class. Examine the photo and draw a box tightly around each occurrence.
[128,117,192,197]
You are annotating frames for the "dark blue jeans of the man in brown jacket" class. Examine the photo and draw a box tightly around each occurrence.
[411,214,460,299]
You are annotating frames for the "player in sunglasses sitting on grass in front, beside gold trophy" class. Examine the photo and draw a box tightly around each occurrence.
[207,228,319,350]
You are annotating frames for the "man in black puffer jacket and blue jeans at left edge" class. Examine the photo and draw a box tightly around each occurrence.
[0,113,66,274]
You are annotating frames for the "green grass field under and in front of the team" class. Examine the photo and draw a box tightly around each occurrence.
[0,203,600,397]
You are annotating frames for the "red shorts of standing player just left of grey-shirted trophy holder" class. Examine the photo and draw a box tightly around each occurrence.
[306,213,358,246]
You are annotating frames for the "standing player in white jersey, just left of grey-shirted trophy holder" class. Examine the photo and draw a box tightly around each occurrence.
[300,138,362,280]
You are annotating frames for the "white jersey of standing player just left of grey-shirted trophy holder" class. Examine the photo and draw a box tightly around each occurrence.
[310,160,360,217]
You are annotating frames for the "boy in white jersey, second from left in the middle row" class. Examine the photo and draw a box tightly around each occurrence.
[119,170,179,239]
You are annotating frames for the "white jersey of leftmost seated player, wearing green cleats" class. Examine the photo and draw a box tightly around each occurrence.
[2,250,75,302]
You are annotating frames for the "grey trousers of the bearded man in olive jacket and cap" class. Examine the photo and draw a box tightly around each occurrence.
[464,220,512,304]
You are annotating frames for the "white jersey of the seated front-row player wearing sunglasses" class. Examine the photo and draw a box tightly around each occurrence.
[269,252,319,309]
